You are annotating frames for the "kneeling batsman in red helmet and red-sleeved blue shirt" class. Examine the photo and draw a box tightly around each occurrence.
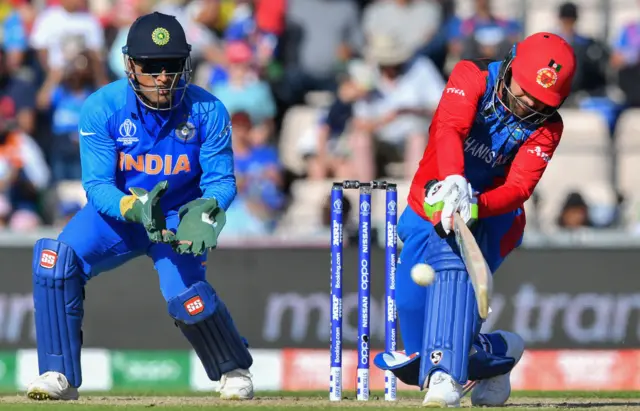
[375,33,576,407]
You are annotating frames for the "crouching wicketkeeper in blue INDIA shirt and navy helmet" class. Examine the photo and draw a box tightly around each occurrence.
[27,13,253,400]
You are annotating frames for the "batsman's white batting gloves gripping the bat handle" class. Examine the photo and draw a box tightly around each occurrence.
[424,175,478,238]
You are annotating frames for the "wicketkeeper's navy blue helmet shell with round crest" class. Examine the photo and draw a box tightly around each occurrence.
[122,12,191,59]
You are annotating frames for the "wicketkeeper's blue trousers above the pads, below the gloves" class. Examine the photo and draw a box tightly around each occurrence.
[58,204,206,301]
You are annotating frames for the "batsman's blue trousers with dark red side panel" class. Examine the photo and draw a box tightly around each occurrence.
[396,207,525,353]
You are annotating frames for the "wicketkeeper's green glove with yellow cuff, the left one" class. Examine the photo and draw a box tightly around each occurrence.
[120,181,173,243]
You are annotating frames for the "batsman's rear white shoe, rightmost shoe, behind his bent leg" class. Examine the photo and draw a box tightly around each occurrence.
[471,331,524,407]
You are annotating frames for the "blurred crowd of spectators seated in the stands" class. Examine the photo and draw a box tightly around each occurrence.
[0,0,640,235]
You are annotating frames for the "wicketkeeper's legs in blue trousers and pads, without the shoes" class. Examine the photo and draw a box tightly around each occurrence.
[33,205,253,387]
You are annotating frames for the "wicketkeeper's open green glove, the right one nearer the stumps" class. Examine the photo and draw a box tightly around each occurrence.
[174,198,227,255]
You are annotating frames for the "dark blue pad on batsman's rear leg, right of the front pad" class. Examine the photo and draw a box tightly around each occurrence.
[469,333,516,381]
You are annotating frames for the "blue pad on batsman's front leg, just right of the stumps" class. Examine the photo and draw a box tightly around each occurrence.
[420,270,482,388]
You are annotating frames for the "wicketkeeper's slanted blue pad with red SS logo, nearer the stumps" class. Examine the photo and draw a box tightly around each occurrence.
[167,281,253,381]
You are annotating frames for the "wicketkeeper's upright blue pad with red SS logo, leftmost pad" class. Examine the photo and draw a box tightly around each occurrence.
[32,238,85,387]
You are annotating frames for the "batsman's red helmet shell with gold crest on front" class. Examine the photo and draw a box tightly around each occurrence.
[511,33,576,107]
